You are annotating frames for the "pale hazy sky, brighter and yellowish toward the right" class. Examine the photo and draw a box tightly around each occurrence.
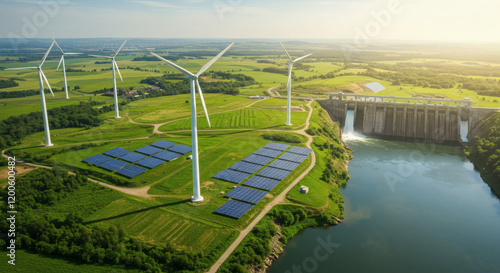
[0,0,500,44]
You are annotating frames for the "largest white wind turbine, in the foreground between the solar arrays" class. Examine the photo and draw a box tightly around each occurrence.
[151,43,234,203]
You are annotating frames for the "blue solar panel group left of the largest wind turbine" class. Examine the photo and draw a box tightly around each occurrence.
[82,140,191,178]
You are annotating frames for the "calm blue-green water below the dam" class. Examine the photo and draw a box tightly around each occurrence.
[267,134,500,273]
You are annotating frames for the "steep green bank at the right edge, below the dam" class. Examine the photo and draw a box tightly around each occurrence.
[466,112,500,194]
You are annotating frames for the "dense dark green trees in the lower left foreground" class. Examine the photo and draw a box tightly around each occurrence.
[0,167,221,272]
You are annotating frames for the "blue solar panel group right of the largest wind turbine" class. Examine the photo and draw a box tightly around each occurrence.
[214,142,313,219]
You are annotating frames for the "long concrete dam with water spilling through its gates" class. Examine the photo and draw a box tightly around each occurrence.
[318,93,495,142]
